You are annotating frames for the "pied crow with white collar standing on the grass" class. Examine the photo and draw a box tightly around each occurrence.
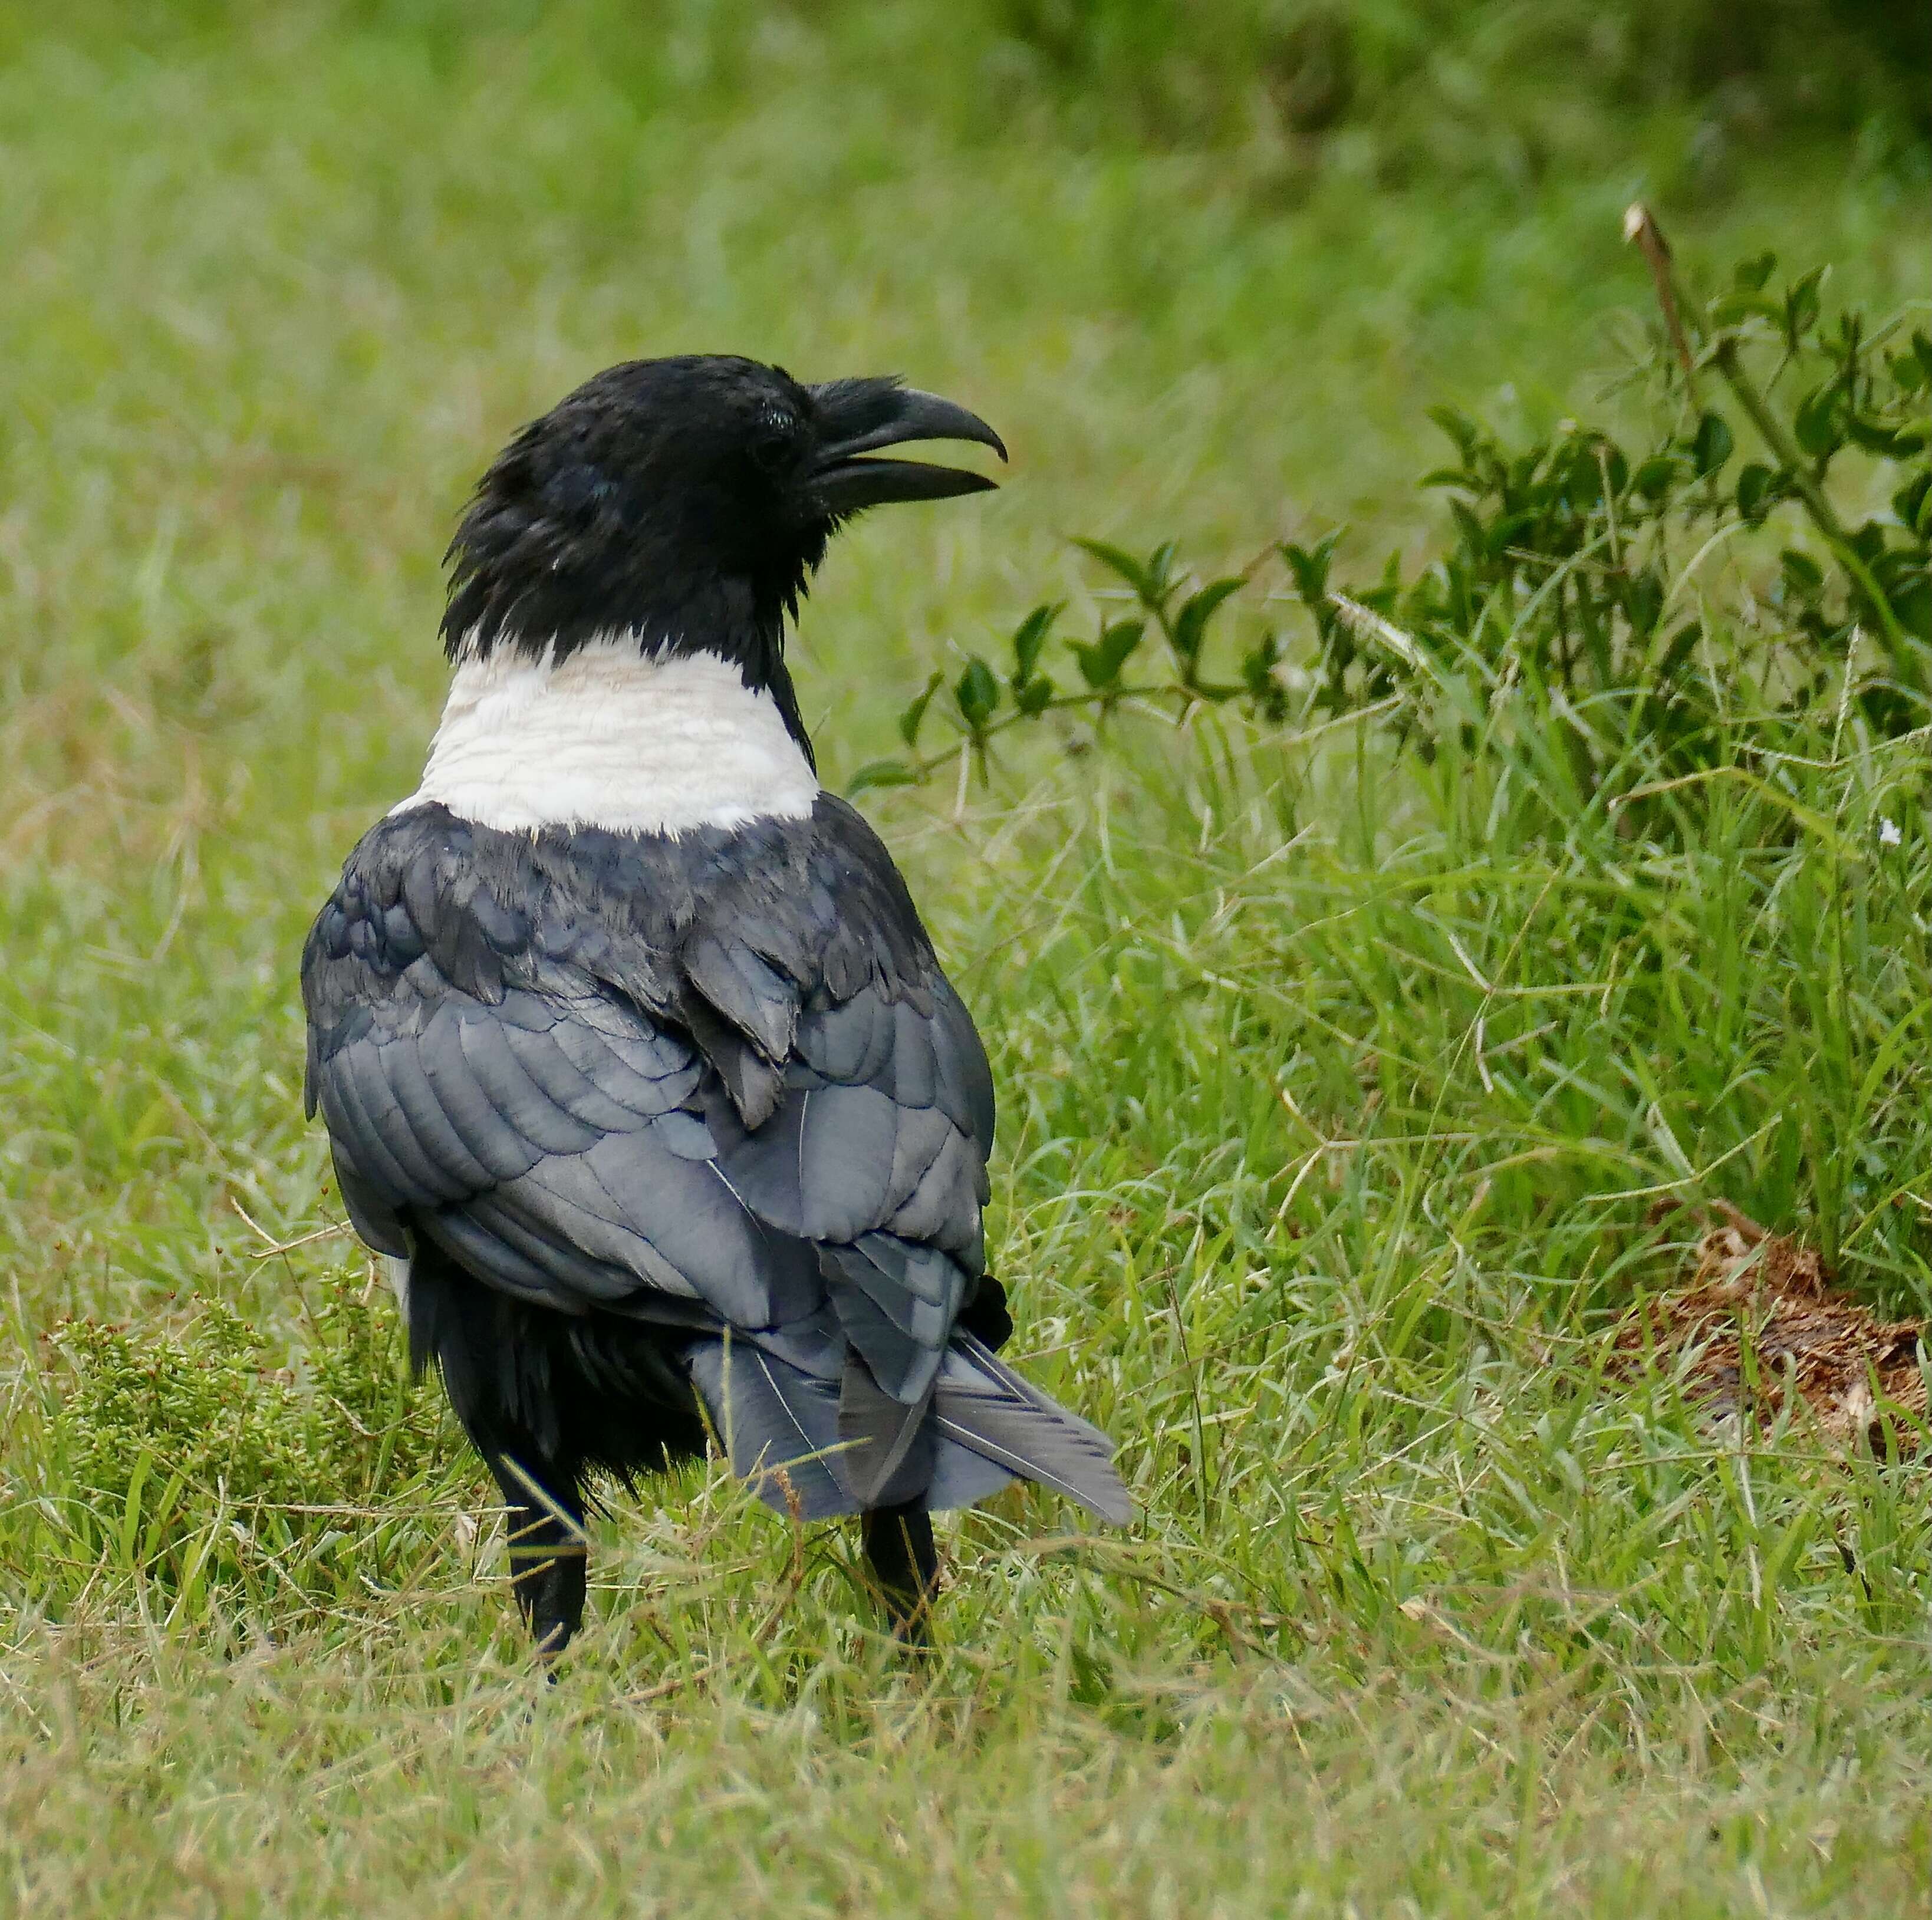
[301,355,1130,1652]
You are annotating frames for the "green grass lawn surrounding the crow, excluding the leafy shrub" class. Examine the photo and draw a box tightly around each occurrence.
[0,6,1932,1920]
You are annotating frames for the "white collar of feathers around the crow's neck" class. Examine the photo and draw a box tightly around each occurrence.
[394,640,819,832]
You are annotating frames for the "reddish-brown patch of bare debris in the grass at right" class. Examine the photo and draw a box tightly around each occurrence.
[1617,1201,1926,1453]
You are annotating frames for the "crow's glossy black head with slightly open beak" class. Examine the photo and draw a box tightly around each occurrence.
[442,355,1006,691]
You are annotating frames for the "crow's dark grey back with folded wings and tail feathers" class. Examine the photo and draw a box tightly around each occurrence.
[303,800,1124,1513]
